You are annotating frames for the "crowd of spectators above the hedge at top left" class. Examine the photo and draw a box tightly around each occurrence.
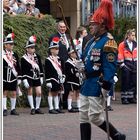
[3,0,40,17]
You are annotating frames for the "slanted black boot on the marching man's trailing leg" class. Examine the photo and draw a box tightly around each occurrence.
[99,121,126,140]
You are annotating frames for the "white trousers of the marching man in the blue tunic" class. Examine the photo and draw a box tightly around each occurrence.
[80,94,104,126]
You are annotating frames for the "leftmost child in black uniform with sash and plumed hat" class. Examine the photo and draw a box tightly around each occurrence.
[3,33,21,116]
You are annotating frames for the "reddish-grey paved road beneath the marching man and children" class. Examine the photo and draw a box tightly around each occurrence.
[3,93,137,140]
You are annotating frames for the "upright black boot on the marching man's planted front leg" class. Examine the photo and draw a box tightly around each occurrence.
[80,123,91,140]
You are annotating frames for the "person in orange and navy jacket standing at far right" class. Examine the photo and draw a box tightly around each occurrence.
[118,29,137,104]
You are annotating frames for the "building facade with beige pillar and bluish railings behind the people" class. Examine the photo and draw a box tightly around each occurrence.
[36,0,137,37]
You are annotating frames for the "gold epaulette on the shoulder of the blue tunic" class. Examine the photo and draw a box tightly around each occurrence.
[103,38,118,53]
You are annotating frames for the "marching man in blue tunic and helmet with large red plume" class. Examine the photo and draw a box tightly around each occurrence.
[80,0,126,140]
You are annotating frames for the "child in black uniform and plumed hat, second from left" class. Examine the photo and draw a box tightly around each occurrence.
[21,36,44,115]
